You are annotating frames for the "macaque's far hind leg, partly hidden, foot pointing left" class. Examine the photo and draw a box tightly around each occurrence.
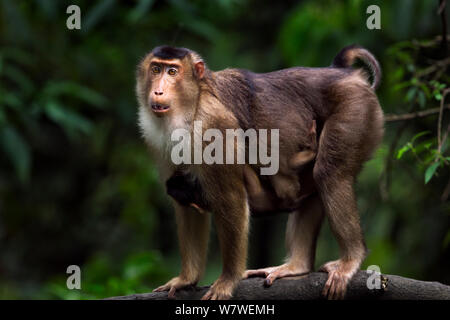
[244,194,324,286]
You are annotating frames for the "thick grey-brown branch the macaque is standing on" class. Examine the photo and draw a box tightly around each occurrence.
[107,271,450,300]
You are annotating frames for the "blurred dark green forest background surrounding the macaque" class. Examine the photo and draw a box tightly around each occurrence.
[0,0,450,299]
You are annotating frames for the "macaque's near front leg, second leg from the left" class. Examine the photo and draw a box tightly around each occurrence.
[202,188,249,300]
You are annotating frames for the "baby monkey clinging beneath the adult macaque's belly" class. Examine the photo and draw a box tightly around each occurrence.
[166,120,317,214]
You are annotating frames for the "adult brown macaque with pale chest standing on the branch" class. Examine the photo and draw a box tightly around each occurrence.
[137,46,383,299]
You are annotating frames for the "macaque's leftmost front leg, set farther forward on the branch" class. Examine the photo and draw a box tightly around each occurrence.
[153,203,210,299]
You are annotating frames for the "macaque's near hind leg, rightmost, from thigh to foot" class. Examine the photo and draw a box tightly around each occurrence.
[313,110,377,299]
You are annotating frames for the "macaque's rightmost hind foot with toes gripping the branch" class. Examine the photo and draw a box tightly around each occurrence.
[319,260,360,300]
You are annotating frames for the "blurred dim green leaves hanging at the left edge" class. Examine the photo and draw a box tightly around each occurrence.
[0,47,106,183]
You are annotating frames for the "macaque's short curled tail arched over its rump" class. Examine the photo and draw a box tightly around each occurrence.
[332,45,381,89]
